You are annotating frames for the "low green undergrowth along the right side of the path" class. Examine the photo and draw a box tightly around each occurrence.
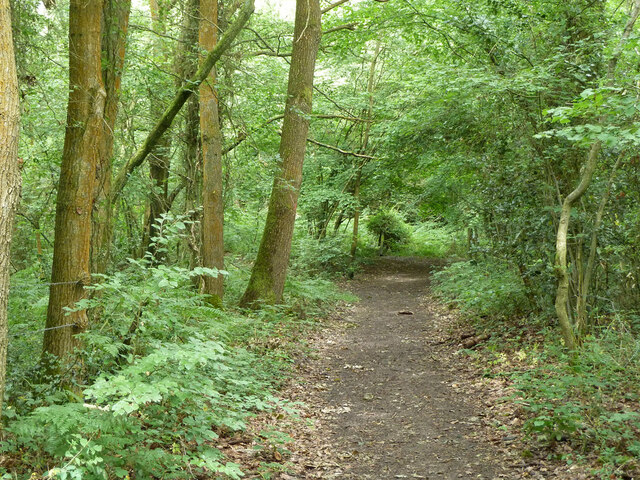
[433,249,640,479]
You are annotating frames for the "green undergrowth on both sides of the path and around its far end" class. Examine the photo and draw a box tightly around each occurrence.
[6,210,640,480]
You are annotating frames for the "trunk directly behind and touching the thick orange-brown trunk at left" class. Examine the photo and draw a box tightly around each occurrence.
[90,0,131,273]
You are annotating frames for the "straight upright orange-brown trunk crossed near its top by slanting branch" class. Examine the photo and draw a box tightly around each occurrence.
[199,0,224,306]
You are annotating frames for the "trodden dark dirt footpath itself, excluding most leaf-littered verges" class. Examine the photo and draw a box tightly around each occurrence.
[283,257,520,480]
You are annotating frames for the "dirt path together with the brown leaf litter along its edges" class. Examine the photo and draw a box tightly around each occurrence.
[222,257,588,480]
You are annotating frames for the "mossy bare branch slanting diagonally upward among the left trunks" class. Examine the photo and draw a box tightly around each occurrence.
[111,0,255,198]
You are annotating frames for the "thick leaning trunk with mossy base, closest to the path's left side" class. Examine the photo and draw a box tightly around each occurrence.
[240,0,322,306]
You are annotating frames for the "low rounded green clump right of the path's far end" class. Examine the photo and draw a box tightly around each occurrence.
[433,260,528,318]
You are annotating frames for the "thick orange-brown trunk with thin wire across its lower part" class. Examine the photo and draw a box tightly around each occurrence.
[43,0,105,370]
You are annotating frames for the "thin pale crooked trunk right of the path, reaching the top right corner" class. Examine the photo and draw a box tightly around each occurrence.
[555,0,640,350]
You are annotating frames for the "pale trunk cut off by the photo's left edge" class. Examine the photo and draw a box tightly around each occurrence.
[0,0,20,422]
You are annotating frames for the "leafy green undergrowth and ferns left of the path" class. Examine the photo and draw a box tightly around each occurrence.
[0,219,352,479]
